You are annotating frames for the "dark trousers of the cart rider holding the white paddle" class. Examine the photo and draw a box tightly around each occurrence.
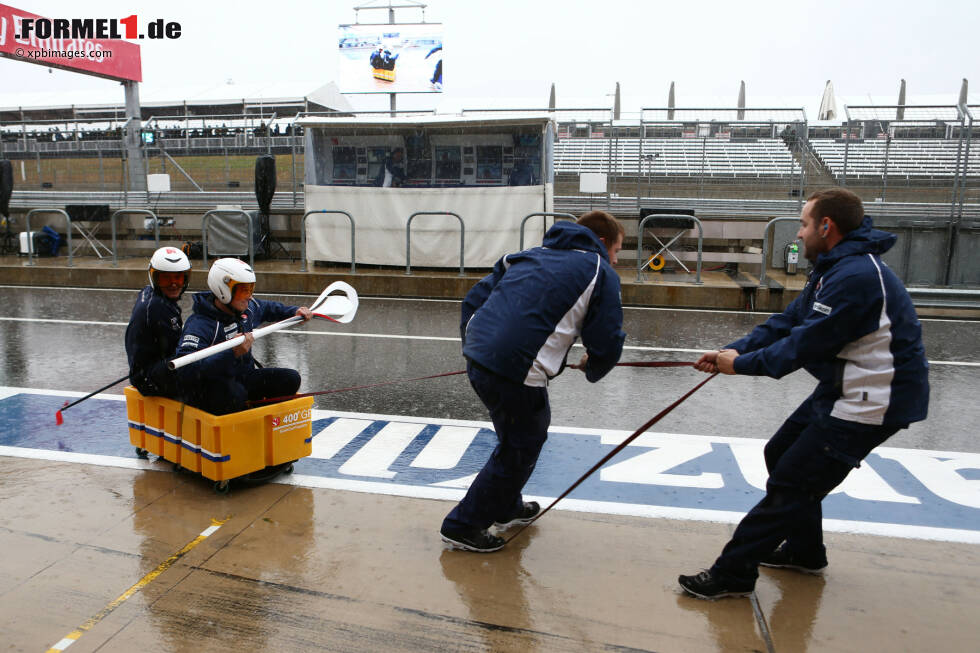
[187,367,300,415]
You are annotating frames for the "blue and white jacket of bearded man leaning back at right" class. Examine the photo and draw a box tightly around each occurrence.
[728,217,929,426]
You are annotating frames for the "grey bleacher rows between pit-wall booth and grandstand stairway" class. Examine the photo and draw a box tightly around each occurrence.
[555,138,800,177]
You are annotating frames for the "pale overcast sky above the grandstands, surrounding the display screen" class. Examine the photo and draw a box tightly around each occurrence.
[0,0,980,111]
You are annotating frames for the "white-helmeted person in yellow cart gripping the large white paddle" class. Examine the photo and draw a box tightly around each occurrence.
[177,258,312,415]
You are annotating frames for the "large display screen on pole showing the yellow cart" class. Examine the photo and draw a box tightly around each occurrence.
[337,23,443,93]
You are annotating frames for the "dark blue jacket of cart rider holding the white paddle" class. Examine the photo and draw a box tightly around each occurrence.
[177,291,298,384]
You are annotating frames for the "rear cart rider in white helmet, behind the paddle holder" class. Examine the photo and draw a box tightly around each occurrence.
[126,247,191,399]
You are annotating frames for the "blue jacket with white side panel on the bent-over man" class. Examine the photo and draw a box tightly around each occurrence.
[460,222,626,386]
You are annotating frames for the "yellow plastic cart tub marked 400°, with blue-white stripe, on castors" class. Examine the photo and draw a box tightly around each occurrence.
[124,386,313,481]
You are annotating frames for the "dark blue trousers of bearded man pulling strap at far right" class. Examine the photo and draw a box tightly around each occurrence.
[711,397,903,583]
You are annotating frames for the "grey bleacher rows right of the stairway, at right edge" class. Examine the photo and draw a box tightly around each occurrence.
[810,138,980,180]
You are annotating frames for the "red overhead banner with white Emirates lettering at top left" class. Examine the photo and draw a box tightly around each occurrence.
[0,3,143,82]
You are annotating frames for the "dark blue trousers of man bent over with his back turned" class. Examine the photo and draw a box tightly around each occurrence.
[443,363,551,529]
